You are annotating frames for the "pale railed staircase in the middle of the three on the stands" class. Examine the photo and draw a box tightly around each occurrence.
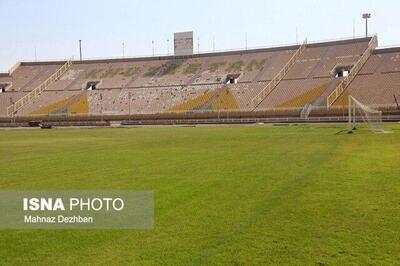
[251,39,307,110]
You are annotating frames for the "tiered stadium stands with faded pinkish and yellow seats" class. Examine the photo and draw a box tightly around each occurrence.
[0,36,400,123]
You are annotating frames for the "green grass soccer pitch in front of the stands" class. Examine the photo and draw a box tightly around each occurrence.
[0,125,400,265]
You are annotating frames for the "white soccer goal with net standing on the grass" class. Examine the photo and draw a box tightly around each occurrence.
[349,96,384,132]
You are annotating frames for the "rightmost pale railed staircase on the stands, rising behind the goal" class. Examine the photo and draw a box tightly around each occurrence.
[326,35,378,107]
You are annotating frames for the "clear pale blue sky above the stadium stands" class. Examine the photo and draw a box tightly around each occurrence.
[0,0,400,72]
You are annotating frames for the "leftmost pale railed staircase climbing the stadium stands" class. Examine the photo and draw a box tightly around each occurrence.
[7,59,72,116]
